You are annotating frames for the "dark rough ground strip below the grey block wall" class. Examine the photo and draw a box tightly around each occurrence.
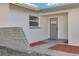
[0,46,48,56]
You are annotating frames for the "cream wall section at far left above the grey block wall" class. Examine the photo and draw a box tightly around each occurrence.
[0,3,9,27]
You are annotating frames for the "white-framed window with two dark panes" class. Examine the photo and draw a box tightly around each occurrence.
[29,16,39,28]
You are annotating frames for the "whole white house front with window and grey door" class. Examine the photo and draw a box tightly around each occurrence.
[0,3,79,46]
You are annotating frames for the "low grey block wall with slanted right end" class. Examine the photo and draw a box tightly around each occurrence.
[0,27,30,52]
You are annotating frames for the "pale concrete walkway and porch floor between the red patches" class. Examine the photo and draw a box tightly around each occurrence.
[31,40,79,56]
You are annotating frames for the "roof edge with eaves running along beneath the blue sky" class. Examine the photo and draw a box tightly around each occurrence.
[12,3,79,12]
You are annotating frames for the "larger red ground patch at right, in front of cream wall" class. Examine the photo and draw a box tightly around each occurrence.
[48,44,79,54]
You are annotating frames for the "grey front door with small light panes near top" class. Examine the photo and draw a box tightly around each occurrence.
[50,18,58,39]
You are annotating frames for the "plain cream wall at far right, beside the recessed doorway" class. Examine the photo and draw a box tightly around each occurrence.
[68,8,79,46]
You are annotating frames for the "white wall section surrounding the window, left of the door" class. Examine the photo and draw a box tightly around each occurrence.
[6,4,48,43]
